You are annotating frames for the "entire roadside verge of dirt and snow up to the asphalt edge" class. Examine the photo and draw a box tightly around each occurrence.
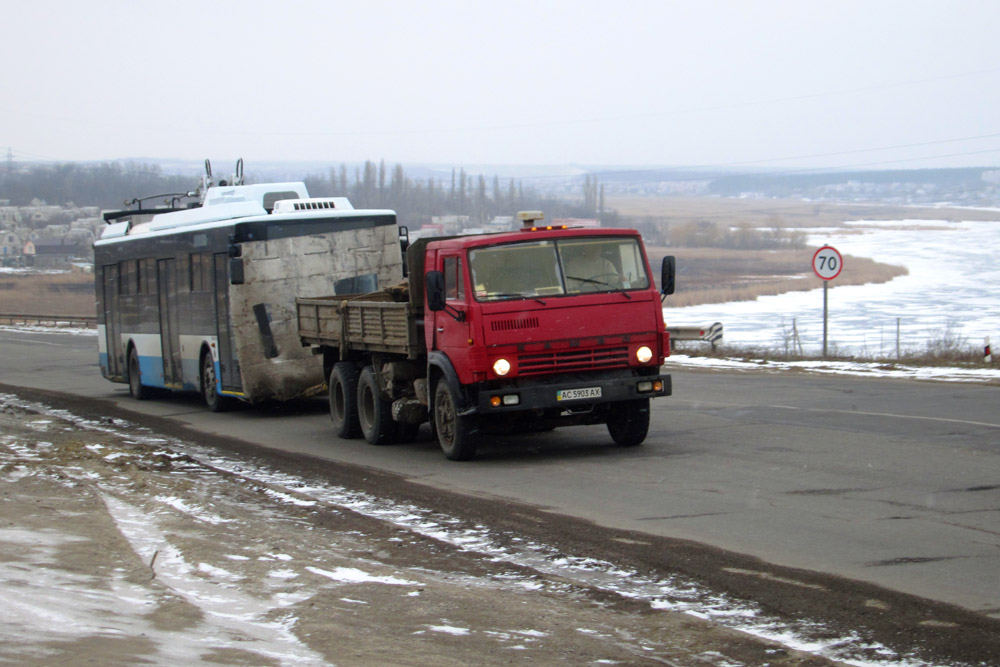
[0,386,1000,665]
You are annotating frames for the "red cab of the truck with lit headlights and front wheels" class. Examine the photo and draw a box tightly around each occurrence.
[424,219,672,458]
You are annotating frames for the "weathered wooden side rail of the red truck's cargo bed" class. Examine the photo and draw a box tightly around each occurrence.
[295,292,426,359]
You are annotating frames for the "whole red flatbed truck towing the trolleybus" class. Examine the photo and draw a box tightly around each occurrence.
[296,212,674,460]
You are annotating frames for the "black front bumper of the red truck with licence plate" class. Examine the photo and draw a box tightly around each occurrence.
[472,371,673,415]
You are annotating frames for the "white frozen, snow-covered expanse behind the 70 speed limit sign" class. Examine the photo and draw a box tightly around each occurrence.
[664,218,1000,355]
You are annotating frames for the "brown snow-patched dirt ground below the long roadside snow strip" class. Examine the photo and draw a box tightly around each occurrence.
[0,388,827,665]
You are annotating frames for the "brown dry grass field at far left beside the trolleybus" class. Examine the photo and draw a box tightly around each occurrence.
[0,273,96,317]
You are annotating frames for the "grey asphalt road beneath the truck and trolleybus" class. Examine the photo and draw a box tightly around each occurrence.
[0,331,1000,618]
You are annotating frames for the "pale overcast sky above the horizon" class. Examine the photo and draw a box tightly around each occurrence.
[0,0,1000,172]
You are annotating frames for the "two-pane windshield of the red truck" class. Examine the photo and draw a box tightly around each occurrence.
[469,236,650,301]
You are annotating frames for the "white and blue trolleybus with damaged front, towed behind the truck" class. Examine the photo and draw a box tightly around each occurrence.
[94,161,405,411]
